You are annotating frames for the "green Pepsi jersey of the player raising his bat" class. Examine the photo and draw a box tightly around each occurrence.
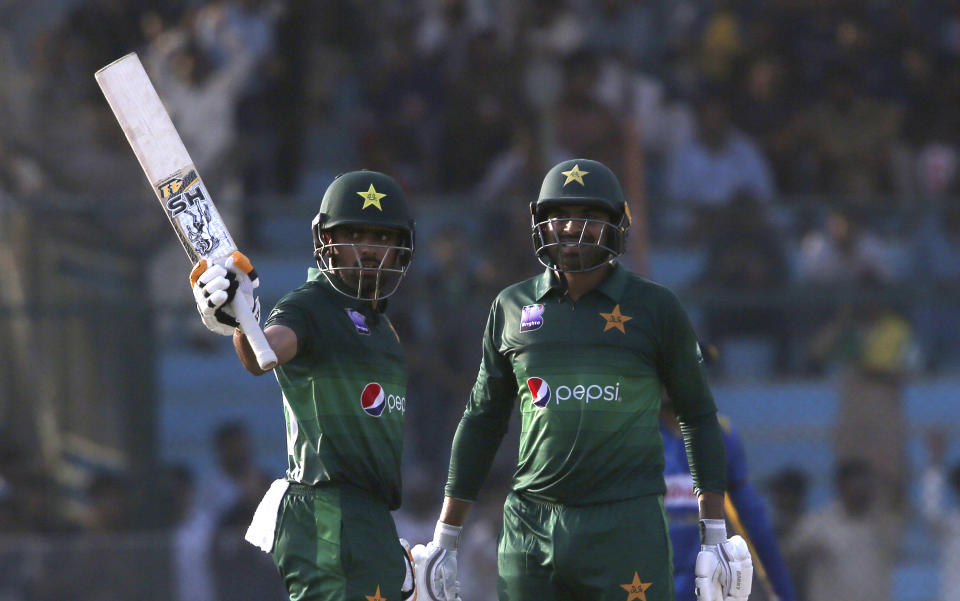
[265,268,407,509]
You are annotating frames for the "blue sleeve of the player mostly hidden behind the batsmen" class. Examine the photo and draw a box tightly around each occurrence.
[721,418,796,601]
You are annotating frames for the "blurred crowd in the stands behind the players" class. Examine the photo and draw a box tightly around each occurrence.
[0,0,960,601]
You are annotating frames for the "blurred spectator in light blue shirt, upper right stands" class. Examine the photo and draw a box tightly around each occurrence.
[666,93,776,208]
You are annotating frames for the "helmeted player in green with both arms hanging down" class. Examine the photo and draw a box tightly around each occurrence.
[413,159,751,601]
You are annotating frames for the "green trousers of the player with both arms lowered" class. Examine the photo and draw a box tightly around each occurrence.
[497,493,673,601]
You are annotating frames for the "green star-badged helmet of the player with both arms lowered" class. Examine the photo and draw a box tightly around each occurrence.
[530,159,631,273]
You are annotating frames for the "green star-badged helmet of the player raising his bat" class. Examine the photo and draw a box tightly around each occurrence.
[312,170,415,300]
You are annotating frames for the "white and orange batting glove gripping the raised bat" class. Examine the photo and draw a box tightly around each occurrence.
[190,251,260,336]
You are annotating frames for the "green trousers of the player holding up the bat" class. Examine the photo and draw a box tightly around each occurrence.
[273,482,406,601]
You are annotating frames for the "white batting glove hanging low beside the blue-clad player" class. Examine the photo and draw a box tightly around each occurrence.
[694,520,753,601]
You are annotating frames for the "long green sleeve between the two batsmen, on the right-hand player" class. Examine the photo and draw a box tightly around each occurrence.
[446,301,517,501]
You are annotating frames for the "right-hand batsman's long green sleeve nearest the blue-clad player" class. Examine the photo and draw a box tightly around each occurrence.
[657,288,726,492]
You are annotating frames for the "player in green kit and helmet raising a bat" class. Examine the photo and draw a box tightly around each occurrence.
[190,171,414,601]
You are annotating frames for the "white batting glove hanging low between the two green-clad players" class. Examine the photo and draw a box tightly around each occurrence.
[411,522,462,601]
